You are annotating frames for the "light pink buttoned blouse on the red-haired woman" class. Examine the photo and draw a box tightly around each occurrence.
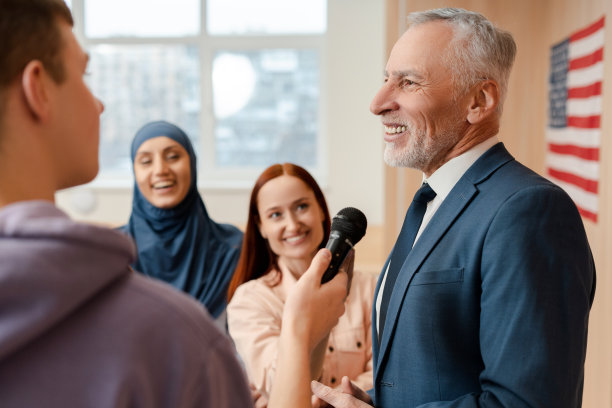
[227,271,377,394]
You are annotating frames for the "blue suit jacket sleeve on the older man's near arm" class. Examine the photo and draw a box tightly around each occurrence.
[419,185,595,408]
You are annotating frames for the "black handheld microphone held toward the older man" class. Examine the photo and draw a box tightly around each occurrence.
[321,207,368,283]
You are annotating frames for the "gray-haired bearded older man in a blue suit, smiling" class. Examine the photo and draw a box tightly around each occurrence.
[312,9,595,408]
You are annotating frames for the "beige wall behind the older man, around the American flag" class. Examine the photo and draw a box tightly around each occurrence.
[383,0,612,408]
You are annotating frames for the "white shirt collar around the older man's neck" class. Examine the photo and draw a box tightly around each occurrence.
[423,136,499,202]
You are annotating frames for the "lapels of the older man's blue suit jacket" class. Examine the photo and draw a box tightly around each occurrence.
[372,143,514,381]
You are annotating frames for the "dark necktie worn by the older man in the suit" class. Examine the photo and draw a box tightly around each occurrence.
[378,183,436,339]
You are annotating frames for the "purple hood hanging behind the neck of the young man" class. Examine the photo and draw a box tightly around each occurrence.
[0,201,135,361]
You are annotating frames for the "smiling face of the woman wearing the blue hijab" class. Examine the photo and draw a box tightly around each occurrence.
[134,136,191,209]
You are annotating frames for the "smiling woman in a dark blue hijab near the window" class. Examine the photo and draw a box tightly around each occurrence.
[121,121,242,325]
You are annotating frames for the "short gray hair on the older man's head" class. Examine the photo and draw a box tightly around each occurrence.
[408,8,516,114]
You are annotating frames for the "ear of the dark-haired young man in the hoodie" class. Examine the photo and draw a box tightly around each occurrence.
[21,60,51,121]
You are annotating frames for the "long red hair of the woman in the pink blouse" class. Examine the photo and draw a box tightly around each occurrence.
[227,163,331,302]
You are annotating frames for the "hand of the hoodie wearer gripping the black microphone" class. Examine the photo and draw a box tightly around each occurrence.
[281,248,348,353]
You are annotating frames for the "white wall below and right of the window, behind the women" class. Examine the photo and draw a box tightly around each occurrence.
[56,0,385,227]
